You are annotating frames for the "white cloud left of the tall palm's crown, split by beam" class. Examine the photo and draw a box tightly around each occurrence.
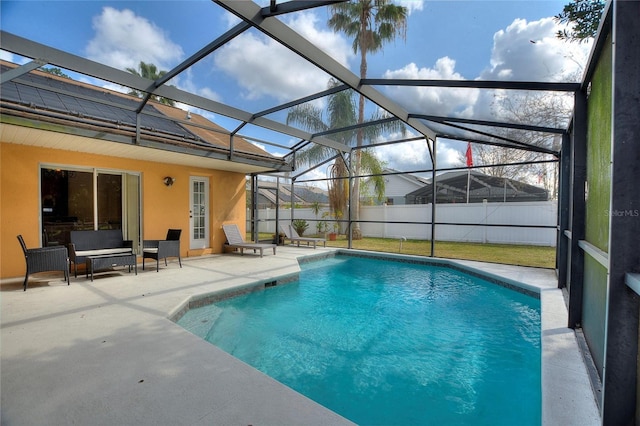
[214,13,356,101]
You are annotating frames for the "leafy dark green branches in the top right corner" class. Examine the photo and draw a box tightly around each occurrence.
[555,0,605,42]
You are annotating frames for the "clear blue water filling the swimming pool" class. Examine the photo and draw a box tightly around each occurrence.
[178,256,541,425]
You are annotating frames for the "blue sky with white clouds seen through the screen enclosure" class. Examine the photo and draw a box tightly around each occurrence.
[0,0,591,181]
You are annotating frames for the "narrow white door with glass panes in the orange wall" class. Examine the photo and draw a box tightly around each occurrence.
[189,176,209,249]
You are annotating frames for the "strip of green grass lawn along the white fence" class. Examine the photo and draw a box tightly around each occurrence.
[261,234,556,269]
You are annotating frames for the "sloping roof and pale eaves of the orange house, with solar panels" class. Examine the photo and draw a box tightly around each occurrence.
[0,61,286,173]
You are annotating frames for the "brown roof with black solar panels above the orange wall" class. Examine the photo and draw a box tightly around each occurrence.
[0,61,286,172]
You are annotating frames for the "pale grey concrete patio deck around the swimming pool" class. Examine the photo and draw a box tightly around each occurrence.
[0,246,600,425]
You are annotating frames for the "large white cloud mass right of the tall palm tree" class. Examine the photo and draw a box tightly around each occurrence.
[377,18,591,170]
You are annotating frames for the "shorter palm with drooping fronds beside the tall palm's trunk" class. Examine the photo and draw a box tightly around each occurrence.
[287,79,405,235]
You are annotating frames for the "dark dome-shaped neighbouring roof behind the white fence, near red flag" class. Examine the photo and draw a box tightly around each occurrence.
[406,171,549,204]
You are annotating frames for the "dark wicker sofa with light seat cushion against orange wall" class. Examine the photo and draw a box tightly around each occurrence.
[69,229,133,277]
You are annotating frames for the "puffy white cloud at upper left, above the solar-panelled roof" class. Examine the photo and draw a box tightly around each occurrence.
[86,7,183,70]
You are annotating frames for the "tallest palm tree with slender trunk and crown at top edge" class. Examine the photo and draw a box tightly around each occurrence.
[328,0,407,239]
